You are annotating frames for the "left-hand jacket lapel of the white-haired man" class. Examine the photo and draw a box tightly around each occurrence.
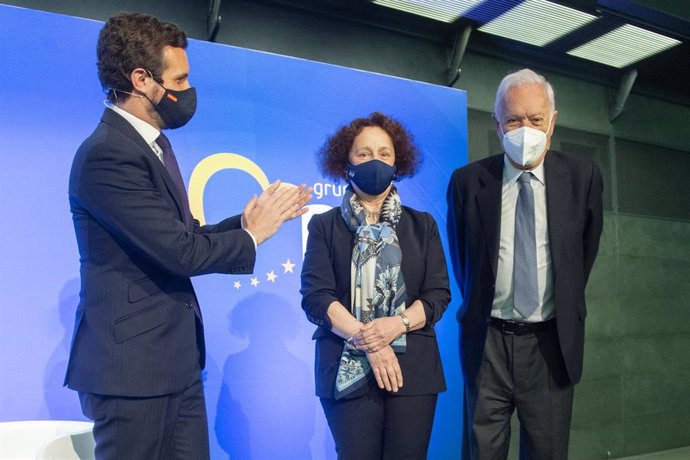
[477,155,503,278]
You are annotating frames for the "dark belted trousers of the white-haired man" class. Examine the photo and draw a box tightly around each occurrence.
[464,326,573,460]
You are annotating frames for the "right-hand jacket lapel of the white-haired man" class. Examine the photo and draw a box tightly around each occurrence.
[544,151,572,273]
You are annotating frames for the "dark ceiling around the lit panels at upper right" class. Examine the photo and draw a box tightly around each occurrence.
[265,0,690,106]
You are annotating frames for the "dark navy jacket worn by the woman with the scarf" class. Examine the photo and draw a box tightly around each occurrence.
[301,206,450,398]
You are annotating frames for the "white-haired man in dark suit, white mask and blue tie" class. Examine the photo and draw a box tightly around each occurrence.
[448,69,603,459]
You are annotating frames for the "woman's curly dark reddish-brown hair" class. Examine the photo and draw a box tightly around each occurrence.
[316,112,422,181]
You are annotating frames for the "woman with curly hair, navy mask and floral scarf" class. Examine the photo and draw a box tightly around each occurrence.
[301,113,450,460]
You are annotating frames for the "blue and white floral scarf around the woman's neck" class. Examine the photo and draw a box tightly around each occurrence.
[335,186,407,399]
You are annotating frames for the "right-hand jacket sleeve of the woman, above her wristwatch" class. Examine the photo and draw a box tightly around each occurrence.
[414,214,450,327]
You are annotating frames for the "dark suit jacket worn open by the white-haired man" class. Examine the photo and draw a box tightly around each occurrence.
[447,150,603,383]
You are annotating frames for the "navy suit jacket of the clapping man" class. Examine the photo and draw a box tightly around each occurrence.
[65,109,256,397]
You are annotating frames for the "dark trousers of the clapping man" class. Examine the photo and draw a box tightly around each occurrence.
[79,376,209,460]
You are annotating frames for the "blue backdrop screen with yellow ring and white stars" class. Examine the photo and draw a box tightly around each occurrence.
[0,5,467,459]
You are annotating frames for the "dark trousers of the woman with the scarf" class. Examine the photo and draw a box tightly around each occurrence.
[321,389,438,460]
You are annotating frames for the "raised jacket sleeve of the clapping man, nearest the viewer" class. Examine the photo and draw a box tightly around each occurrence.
[77,142,256,277]
